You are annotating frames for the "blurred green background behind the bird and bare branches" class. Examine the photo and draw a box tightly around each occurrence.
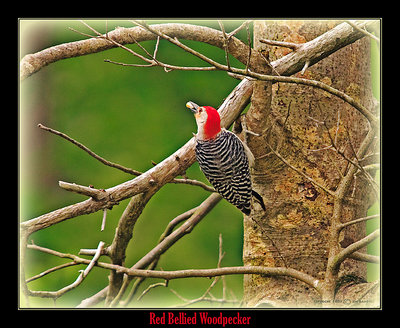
[19,20,379,307]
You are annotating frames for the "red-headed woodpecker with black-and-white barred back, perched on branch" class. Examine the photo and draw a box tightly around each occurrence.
[186,101,265,215]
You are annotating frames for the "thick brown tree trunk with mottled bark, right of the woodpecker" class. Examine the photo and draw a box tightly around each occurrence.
[241,21,373,307]
